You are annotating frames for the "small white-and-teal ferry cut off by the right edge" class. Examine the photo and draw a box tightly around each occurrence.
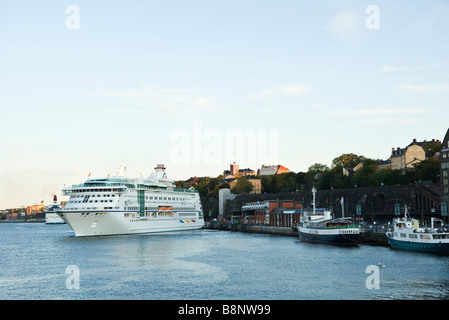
[386,207,449,254]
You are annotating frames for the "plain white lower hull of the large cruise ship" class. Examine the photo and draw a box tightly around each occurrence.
[58,211,204,237]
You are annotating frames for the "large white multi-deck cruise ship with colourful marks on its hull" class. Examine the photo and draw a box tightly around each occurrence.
[55,163,204,236]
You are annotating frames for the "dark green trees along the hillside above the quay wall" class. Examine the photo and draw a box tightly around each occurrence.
[186,153,440,199]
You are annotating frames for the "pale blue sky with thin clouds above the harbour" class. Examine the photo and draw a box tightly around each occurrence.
[0,0,449,209]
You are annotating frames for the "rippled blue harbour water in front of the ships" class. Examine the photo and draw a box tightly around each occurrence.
[0,223,449,300]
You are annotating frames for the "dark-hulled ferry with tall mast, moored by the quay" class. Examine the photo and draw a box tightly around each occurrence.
[297,188,360,246]
